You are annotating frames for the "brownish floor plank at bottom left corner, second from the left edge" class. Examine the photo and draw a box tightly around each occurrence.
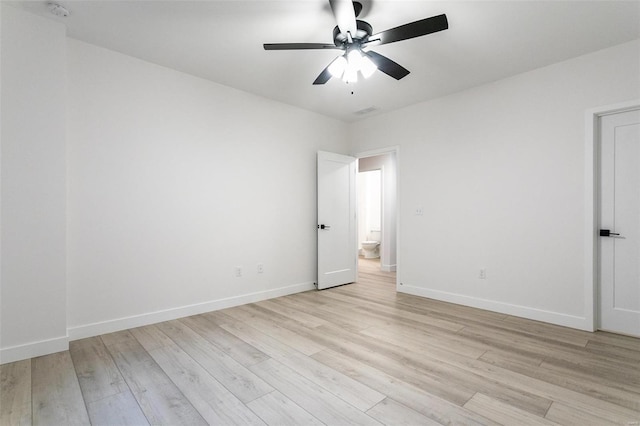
[31,351,89,425]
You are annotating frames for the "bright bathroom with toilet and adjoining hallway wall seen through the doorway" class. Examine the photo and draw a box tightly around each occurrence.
[357,152,397,272]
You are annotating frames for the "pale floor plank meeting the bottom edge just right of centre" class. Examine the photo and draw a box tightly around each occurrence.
[250,359,380,425]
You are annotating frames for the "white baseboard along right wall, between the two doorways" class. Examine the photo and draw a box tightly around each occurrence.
[397,284,593,331]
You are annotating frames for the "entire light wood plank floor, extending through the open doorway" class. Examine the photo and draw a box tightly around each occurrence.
[0,261,640,425]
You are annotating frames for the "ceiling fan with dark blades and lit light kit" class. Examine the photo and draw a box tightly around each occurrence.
[263,0,449,84]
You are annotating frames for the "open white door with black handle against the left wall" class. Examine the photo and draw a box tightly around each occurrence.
[318,151,358,290]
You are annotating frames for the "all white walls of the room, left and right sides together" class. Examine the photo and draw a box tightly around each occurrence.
[0,4,640,363]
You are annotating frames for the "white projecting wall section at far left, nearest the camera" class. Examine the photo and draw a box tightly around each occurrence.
[0,4,68,362]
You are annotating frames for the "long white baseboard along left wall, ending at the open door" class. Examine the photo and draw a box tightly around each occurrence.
[67,282,315,341]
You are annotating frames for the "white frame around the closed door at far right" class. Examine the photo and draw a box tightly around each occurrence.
[584,99,640,331]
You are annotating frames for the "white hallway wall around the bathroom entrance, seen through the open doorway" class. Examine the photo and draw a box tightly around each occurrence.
[358,152,397,271]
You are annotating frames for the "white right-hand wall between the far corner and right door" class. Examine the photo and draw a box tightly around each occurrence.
[350,41,640,329]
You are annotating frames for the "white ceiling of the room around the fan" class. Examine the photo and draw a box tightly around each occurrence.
[10,0,640,121]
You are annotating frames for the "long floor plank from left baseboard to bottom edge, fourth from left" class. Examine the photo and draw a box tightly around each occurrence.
[107,332,207,425]
